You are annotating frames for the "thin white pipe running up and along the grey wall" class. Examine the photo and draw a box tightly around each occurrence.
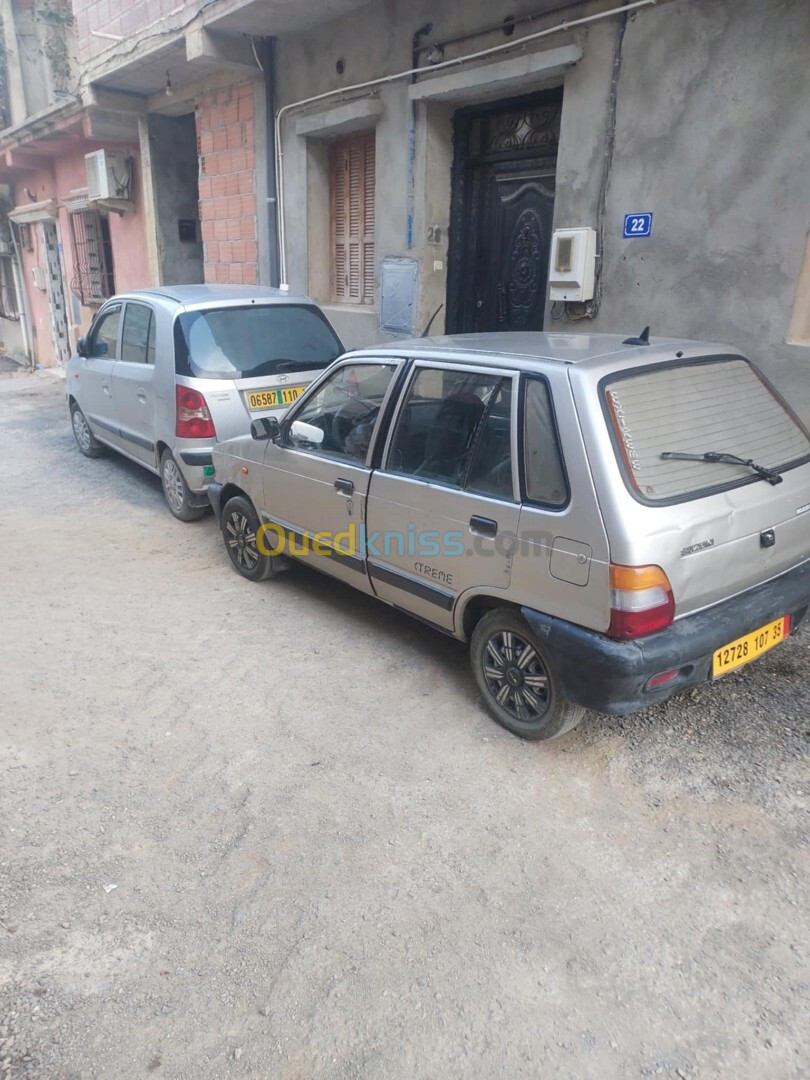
[275,0,665,288]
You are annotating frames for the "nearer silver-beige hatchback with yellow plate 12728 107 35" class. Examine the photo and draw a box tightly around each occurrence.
[204,334,810,740]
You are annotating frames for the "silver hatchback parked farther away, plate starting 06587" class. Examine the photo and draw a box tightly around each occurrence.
[67,285,342,522]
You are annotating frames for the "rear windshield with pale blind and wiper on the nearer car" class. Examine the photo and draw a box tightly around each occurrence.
[602,357,810,502]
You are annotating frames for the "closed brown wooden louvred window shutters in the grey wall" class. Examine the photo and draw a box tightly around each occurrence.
[329,132,375,303]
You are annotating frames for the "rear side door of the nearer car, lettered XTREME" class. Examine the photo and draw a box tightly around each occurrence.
[366,362,521,630]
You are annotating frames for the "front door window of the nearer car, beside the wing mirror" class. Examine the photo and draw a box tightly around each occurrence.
[282,364,395,464]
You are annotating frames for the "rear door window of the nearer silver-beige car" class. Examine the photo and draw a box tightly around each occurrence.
[388,368,513,499]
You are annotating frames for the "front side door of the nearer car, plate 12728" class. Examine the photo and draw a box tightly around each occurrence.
[262,359,402,593]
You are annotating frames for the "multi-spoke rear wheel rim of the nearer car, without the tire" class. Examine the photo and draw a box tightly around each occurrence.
[483,630,551,724]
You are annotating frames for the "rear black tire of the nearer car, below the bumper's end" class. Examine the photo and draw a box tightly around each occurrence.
[470,608,585,742]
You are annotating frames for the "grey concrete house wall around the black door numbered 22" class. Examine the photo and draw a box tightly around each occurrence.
[278,0,810,414]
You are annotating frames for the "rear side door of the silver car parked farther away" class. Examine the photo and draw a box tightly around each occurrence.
[112,300,156,464]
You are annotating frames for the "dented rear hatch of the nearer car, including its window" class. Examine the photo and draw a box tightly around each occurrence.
[600,356,810,617]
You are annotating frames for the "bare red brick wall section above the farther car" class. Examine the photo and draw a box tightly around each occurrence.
[197,82,258,285]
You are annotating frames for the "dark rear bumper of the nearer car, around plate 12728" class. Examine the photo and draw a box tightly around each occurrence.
[522,562,810,715]
